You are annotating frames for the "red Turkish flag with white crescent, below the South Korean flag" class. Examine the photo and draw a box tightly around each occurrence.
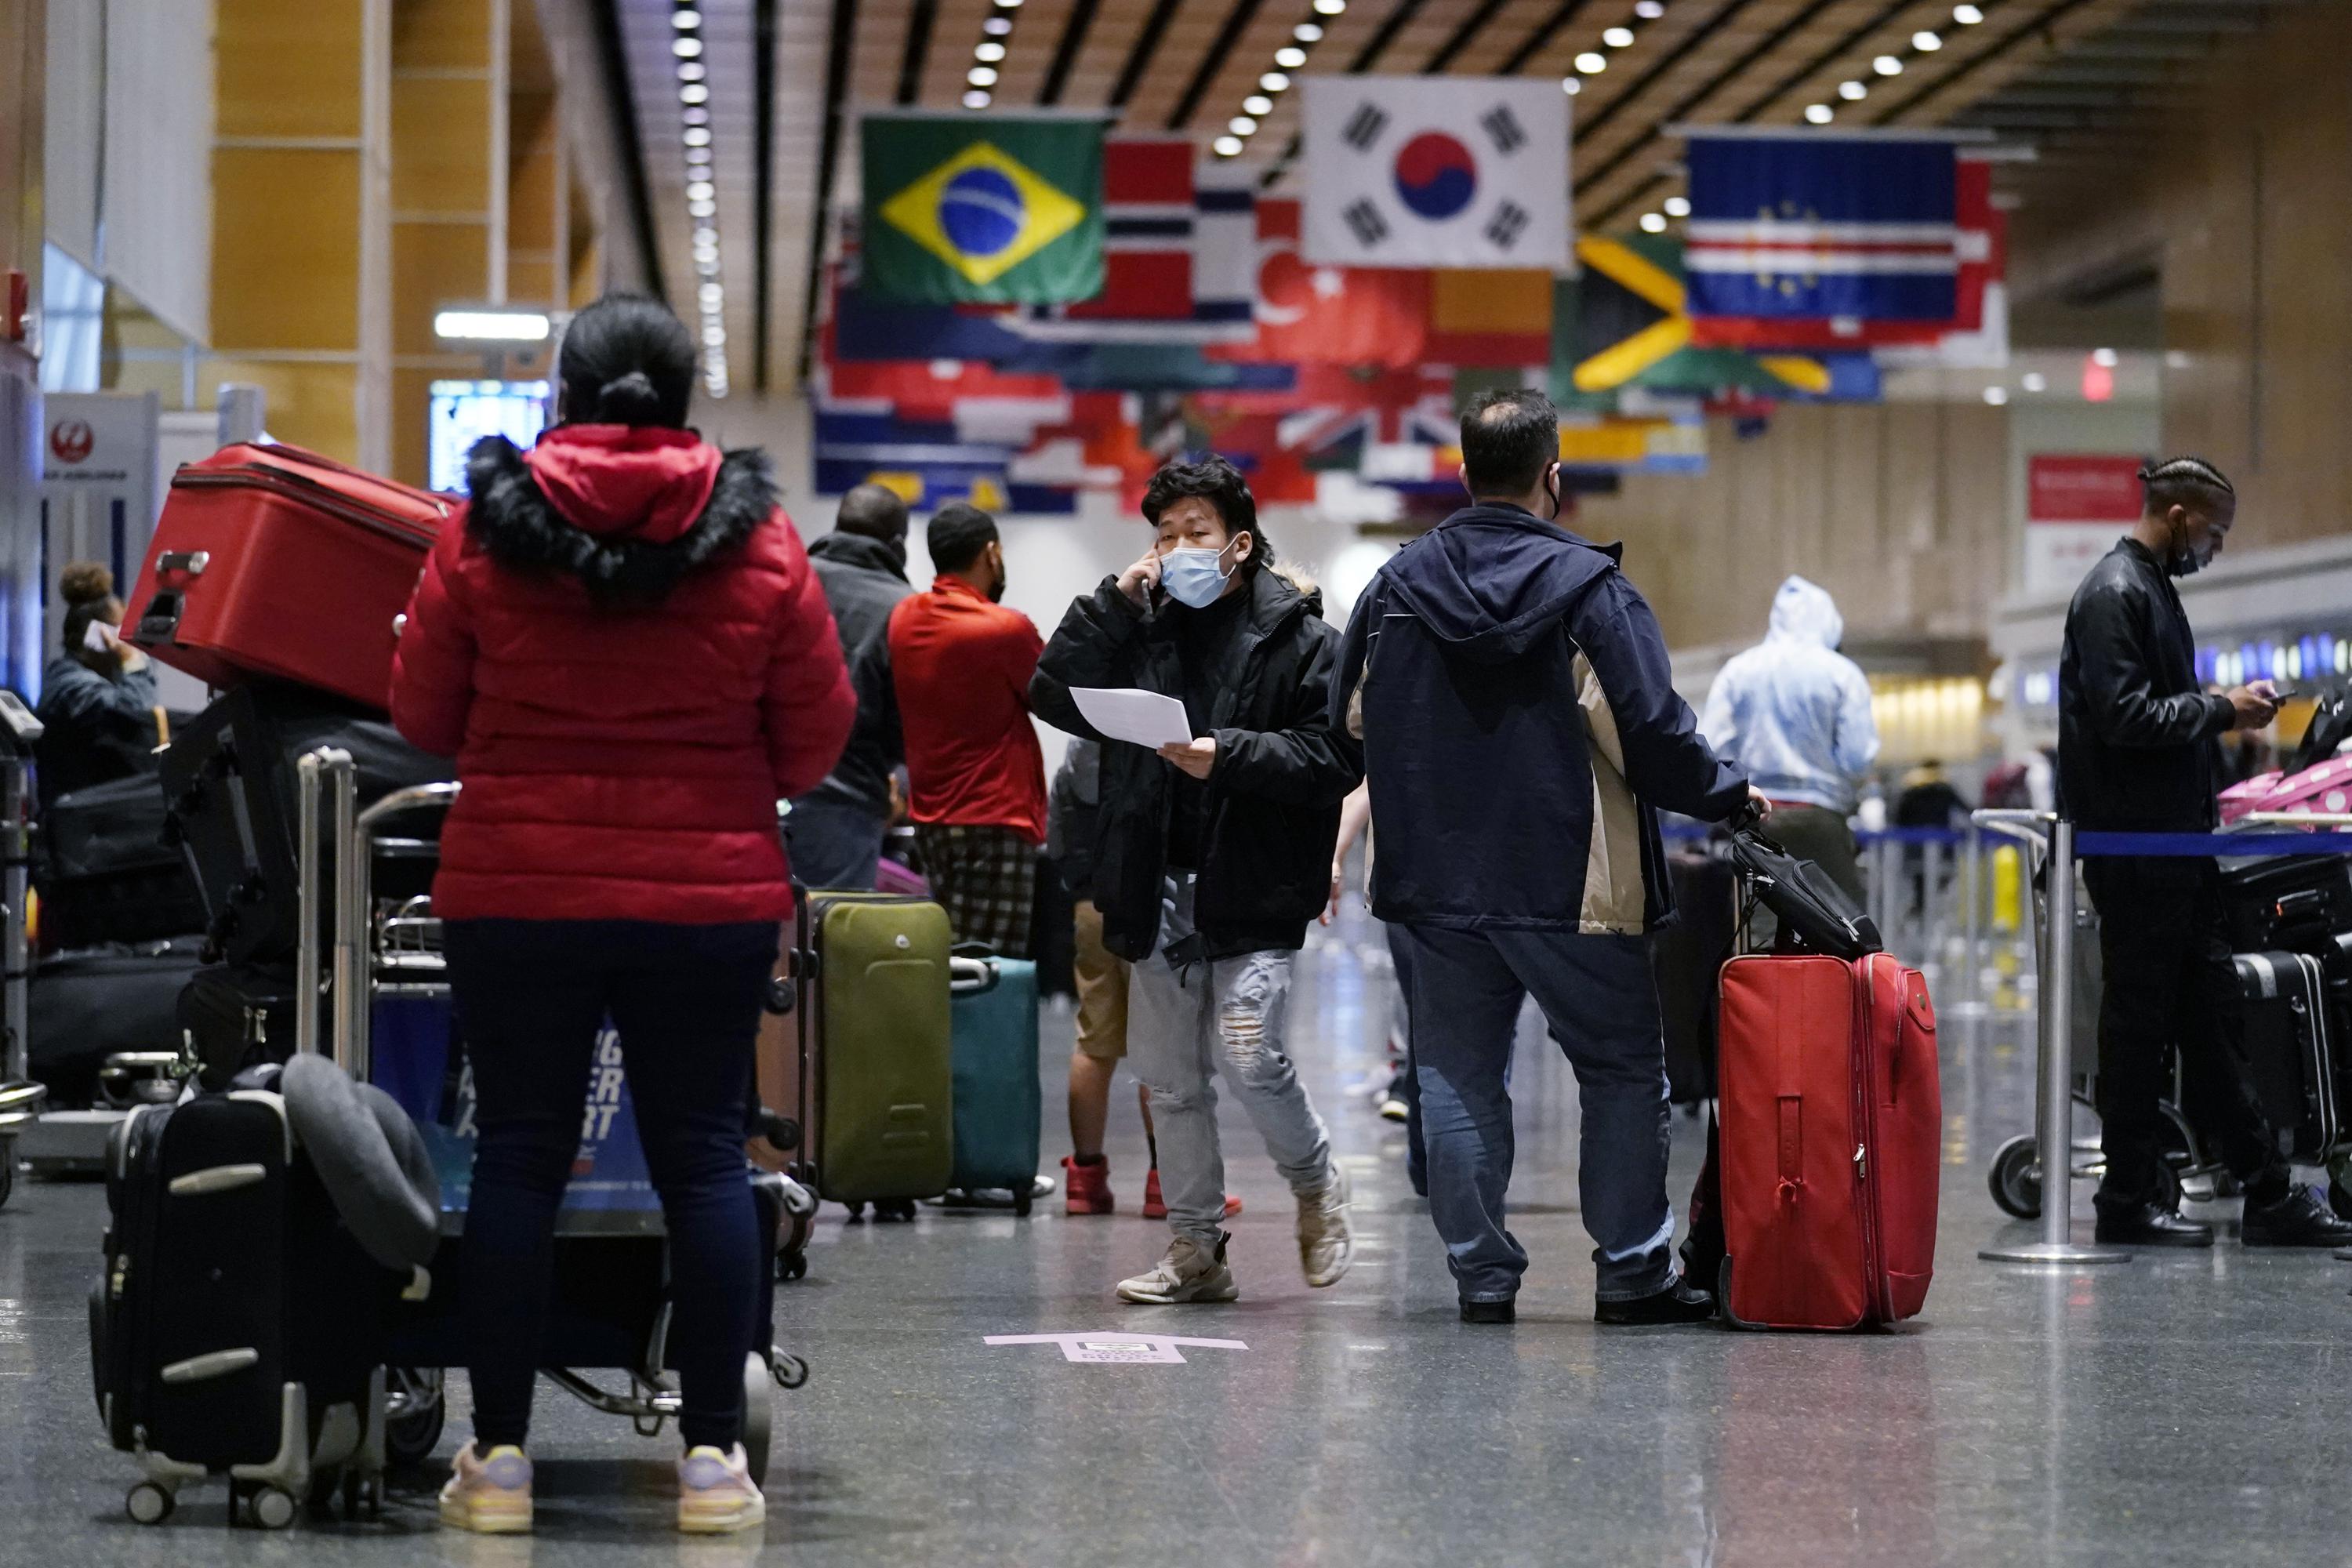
[1209,200,1430,367]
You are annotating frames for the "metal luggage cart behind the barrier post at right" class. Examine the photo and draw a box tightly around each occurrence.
[1976,811,2237,1220]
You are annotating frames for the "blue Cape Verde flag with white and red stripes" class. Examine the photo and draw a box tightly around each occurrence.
[1682,134,1959,322]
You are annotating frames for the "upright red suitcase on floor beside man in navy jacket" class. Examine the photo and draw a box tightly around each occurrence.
[1719,952,1943,1328]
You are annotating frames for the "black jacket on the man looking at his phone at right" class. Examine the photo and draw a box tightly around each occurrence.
[2058,539,2237,832]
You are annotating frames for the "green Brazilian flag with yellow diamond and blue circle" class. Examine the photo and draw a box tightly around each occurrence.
[858,115,1103,306]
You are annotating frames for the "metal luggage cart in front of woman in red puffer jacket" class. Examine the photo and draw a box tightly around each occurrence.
[294,748,816,1476]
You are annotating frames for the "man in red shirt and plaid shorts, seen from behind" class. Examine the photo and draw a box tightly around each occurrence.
[889,501,1044,959]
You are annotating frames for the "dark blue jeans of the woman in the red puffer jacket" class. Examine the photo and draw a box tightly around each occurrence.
[442,919,776,1453]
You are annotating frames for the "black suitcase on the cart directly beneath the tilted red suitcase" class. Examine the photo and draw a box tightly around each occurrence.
[162,682,452,966]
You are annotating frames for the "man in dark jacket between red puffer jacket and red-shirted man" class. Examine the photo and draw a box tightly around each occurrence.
[790,485,913,888]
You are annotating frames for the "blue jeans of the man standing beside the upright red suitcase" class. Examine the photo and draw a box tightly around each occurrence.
[1404,926,1675,1300]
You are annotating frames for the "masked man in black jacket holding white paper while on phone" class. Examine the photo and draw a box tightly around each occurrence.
[1030,456,1362,1302]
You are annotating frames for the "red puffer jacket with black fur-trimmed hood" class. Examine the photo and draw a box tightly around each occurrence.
[393,426,856,924]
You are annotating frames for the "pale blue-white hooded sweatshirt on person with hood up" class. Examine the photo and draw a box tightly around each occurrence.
[1698,576,1879,815]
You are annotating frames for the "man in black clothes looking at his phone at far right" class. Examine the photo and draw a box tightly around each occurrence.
[2058,459,2352,1246]
